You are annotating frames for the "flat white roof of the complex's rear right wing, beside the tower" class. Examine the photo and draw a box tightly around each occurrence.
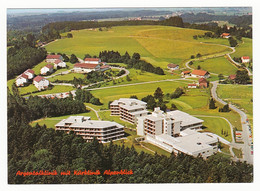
[167,110,204,126]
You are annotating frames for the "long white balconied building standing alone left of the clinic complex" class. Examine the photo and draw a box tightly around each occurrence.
[55,116,124,143]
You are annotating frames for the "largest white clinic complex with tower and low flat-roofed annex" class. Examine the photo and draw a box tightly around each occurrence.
[137,108,218,158]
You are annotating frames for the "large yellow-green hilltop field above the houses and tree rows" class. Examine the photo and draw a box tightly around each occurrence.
[46,26,230,62]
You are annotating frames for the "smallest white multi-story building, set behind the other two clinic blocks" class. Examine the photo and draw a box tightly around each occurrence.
[110,98,149,123]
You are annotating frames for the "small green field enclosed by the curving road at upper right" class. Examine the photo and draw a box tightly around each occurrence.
[191,57,237,75]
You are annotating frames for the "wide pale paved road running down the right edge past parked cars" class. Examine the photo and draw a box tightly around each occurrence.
[211,81,253,164]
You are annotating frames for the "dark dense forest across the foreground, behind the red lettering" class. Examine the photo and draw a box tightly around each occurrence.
[8,91,253,184]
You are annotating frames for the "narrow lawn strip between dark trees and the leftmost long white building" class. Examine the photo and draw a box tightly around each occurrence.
[30,110,97,128]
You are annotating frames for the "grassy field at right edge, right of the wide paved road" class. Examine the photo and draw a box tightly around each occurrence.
[217,85,253,128]
